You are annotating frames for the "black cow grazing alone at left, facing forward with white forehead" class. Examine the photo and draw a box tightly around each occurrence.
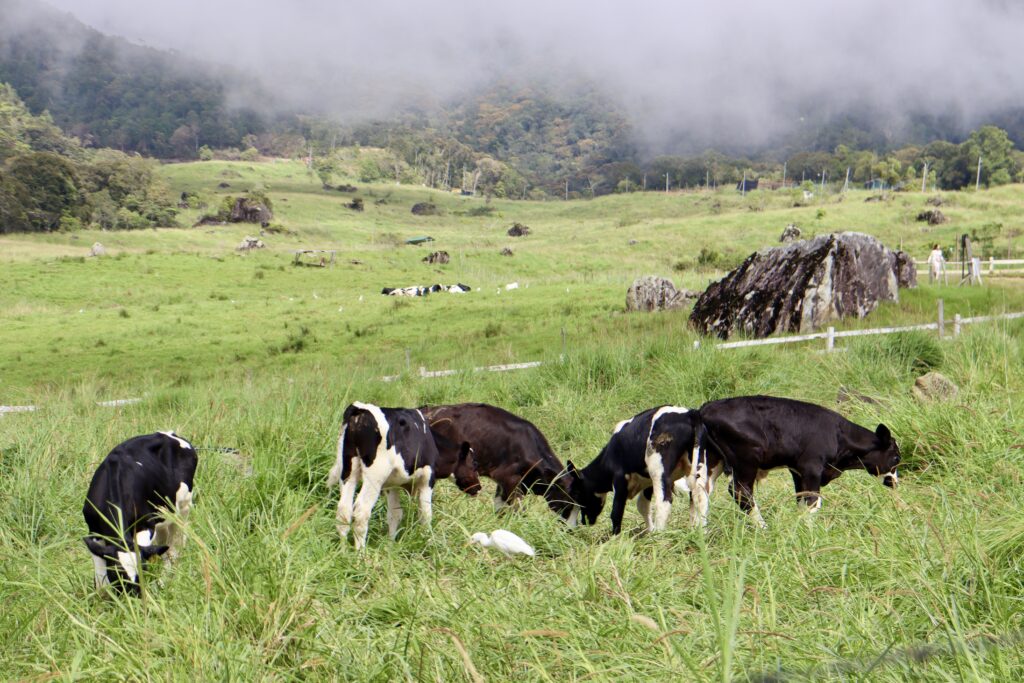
[82,432,199,595]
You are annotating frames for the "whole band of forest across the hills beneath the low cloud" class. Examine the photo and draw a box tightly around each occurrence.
[0,0,1024,209]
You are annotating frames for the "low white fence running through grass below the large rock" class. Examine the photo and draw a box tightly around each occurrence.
[0,309,1024,417]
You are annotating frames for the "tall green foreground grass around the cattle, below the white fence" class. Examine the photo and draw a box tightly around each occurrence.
[0,325,1024,681]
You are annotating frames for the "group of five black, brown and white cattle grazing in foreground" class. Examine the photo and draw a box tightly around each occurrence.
[83,396,900,594]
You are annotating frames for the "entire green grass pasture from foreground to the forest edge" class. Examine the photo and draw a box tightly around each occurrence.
[0,162,1024,681]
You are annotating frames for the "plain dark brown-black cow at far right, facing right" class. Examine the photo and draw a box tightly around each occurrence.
[699,396,900,526]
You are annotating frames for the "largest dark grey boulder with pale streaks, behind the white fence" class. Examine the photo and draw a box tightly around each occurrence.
[690,232,899,339]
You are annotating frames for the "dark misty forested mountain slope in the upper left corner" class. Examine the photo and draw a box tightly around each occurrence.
[0,0,264,159]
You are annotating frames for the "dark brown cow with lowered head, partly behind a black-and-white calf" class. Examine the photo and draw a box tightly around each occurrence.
[422,403,585,526]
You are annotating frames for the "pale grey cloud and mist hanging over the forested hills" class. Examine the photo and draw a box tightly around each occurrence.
[39,0,1024,150]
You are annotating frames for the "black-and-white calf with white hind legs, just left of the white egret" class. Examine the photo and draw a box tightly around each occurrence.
[328,401,480,549]
